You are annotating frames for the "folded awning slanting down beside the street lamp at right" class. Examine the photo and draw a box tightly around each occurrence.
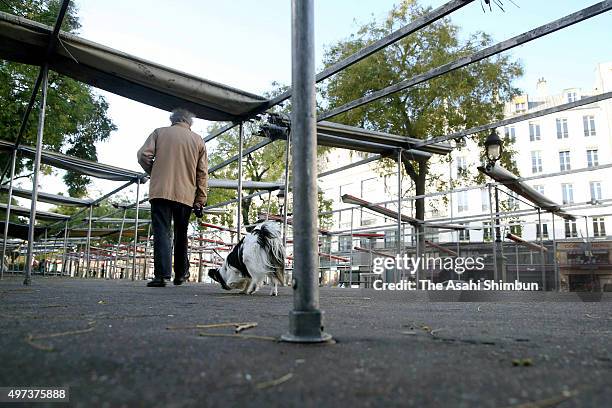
[478,164,576,220]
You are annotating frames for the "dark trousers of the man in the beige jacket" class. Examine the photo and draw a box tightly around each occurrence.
[151,198,191,279]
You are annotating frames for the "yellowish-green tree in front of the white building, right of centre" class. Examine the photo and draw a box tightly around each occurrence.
[324,0,522,252]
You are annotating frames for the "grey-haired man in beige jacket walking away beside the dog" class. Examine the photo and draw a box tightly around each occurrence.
[138,109,208,287]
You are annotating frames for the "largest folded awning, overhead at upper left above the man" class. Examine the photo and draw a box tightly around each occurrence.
[0,13,268,121]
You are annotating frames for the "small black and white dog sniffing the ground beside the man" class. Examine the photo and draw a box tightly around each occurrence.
[208,221,285,296]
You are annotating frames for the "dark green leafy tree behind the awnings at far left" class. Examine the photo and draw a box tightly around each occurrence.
[0,0,116,197]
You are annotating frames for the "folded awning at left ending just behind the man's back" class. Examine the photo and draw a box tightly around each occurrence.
[0,138,146,181]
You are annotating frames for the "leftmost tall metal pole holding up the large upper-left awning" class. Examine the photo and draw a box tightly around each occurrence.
[23,63,49,285]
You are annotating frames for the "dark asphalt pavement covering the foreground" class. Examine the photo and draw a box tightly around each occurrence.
[0,275,612,408]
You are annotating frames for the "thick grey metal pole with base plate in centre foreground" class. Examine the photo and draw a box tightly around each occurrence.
[282,0,331,343]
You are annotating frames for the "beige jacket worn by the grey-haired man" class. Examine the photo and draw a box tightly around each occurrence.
[138,122,208,207]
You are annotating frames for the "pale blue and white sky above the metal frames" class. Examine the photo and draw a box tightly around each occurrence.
[24,0,612,209]
